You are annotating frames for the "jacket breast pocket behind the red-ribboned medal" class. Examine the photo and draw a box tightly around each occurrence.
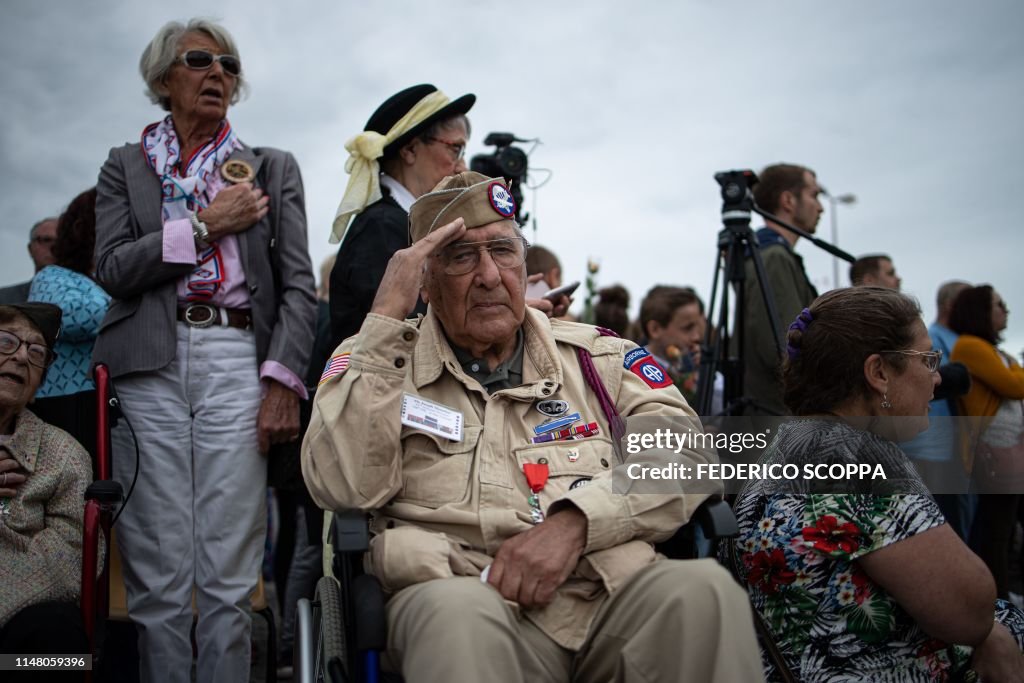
[513,436,614,509]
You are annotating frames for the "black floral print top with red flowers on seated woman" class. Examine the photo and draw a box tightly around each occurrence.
[722,420,1024,683]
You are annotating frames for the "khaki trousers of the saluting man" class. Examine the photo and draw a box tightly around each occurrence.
[385,559,764,683]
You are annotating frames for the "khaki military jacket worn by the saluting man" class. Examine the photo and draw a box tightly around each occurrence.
[302,309,715,649]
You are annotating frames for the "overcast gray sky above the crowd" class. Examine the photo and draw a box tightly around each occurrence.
[0,0,1024,354]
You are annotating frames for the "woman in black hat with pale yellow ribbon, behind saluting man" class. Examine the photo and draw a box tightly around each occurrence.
[331,84,476,348]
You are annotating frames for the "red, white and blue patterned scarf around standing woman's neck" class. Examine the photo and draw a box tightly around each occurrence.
[142,115,242,301]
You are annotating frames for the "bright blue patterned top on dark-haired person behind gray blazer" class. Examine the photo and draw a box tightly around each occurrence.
[29,265,111,398]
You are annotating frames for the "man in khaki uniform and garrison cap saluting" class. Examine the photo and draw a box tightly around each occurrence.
[302,173,761,683]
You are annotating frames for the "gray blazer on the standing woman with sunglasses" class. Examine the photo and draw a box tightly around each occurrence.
[92,143,316,380]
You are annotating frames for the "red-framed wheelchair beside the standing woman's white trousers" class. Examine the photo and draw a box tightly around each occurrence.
[80,364,278,683]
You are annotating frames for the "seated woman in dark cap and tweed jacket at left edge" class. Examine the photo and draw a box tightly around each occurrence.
[0,303,92,663]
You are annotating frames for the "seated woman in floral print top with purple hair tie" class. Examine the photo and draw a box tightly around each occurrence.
[722,287,1024,683]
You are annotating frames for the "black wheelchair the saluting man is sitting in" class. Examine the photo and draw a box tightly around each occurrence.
[294,498,739,683]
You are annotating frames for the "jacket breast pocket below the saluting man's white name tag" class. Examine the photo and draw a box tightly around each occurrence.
[395,425,482,508]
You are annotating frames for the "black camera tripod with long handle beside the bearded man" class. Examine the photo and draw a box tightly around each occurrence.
[696,170,855,416]
